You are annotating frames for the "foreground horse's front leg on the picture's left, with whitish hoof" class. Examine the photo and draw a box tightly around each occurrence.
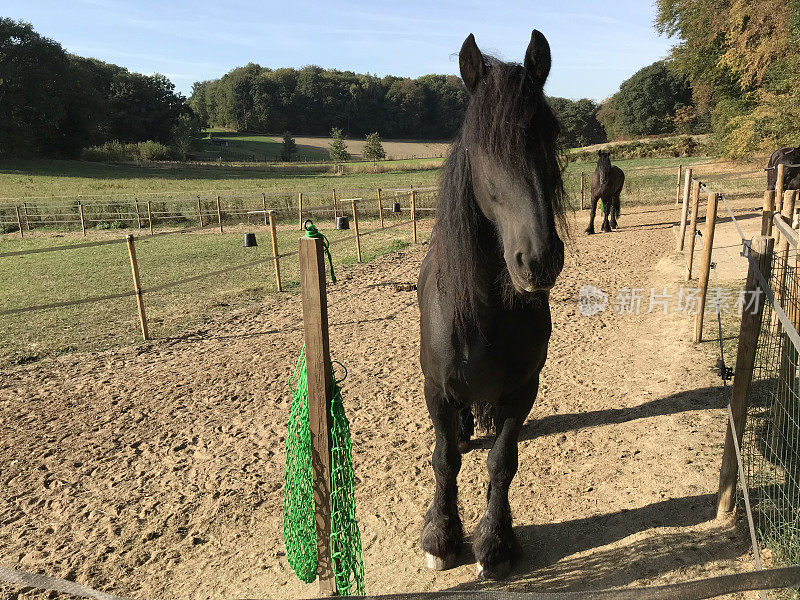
[422,381,464,571]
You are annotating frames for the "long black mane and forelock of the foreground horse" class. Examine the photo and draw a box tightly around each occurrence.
[431,56,565,331]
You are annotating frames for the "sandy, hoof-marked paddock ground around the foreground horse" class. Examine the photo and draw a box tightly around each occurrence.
[0,202,764,600]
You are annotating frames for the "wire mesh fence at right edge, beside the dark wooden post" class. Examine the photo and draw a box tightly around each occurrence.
[740,241,800,584]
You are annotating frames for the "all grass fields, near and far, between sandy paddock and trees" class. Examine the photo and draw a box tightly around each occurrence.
[0,152,764,367]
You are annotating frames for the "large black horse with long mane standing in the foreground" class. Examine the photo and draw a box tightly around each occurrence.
[418,31,564,578]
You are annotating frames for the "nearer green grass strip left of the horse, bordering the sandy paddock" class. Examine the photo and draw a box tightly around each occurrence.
[0,213,429,368]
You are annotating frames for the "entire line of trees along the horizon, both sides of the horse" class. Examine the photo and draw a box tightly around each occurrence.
[9,12,800,162]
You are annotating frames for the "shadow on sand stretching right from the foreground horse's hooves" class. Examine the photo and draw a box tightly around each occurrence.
[444,494,747,592]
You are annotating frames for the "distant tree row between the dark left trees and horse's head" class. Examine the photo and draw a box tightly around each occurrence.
[189,63,469,139]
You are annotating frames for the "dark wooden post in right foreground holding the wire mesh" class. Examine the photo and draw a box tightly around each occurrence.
[717,236,775,519]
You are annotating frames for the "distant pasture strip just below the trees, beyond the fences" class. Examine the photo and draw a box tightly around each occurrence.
[0,158,736,209]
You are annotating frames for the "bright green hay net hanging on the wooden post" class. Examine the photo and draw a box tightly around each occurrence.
[283,346,364,596]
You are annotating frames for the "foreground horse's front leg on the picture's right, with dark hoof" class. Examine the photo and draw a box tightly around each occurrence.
[472,392,539,579]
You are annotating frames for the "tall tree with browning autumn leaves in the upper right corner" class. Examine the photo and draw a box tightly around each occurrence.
[656,0,800,157]
